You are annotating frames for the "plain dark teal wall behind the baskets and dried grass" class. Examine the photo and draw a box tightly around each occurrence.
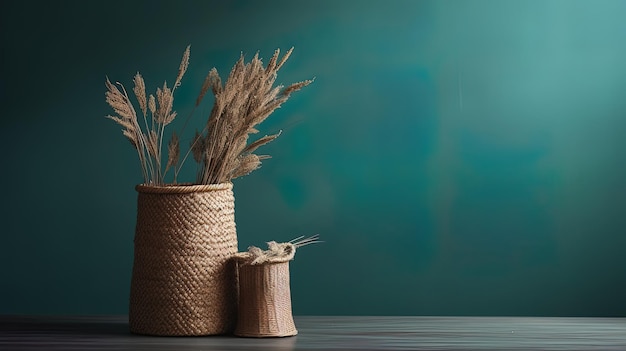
[0,0,626,316]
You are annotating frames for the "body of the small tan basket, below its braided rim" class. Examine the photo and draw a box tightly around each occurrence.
[235,261,298,337]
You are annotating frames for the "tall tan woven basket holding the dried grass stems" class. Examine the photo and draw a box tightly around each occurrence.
[129,183,237,336]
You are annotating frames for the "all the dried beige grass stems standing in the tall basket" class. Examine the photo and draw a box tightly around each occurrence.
[105,46,312,185]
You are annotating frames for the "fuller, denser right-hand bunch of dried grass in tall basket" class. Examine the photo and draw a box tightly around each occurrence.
[192,48,312,184]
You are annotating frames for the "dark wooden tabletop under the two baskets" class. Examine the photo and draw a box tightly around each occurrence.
[0,316,626,351]
